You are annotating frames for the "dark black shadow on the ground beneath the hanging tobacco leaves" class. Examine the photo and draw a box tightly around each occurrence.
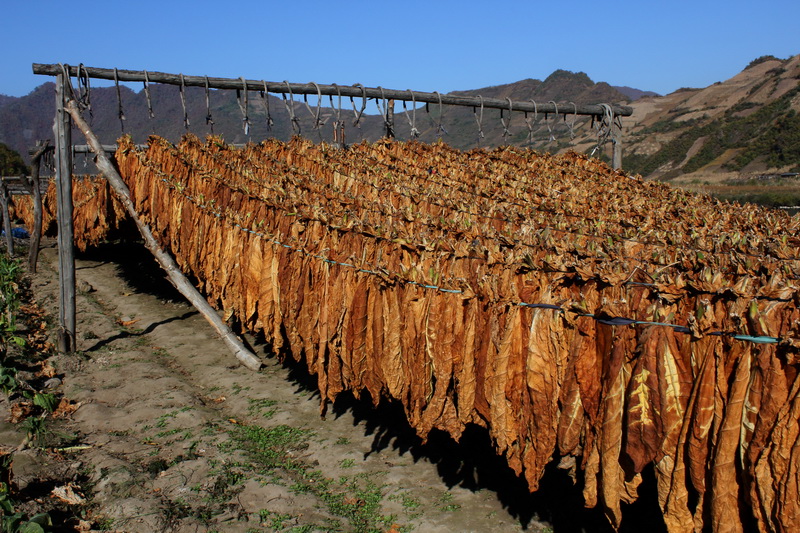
[82,242,666,533]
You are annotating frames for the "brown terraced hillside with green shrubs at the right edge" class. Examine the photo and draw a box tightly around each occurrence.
[623,55,800,182]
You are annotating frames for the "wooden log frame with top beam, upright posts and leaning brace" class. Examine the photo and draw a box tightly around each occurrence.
[33,63,633,360]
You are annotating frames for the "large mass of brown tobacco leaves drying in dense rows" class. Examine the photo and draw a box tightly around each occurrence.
[26,136,800,531]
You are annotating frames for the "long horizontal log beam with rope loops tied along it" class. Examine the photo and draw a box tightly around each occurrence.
[33,63,633,117]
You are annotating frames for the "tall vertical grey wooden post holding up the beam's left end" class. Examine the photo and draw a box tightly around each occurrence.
[53,74,75,353]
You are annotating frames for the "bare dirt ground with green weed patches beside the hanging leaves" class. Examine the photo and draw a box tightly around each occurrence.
[0,239,657,532]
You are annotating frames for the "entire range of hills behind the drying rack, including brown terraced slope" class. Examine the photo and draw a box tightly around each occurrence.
[0,56,800,187]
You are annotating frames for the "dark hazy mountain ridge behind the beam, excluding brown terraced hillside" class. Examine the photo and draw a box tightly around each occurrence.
[0,70,629,164]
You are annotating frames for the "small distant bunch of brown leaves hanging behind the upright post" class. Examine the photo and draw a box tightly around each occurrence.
[12,176,127,251]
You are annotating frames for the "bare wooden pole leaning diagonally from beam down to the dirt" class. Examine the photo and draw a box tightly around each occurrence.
[66,100,261,370]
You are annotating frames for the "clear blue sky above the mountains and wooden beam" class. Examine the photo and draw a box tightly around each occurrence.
[0,0,800,96]
